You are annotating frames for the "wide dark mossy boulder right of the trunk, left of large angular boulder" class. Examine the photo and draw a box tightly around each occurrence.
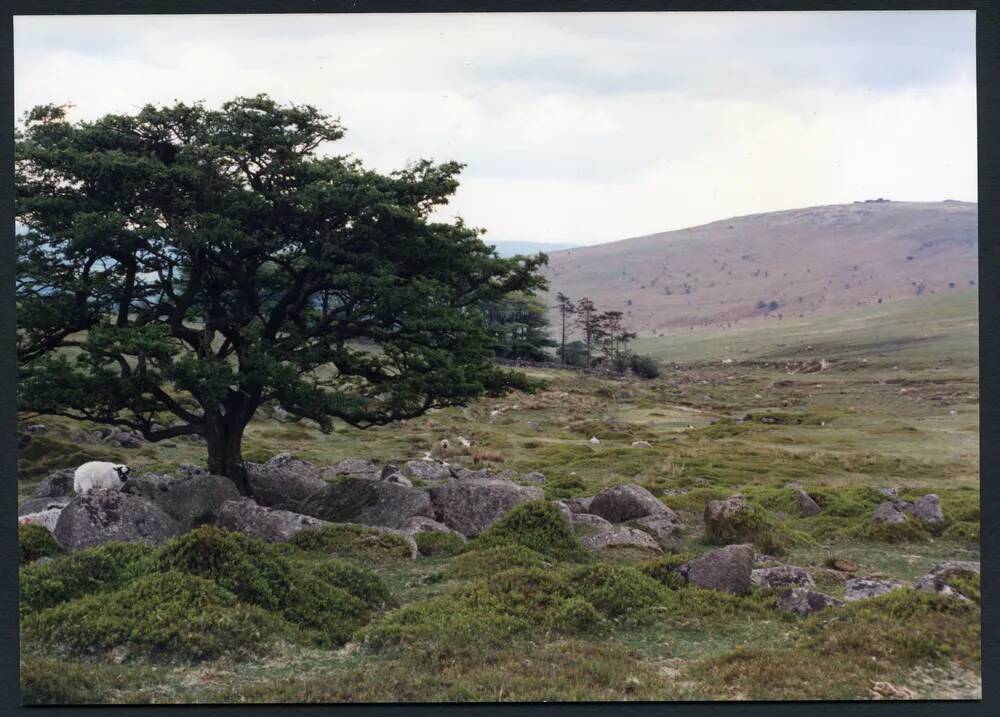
[296,478,434,528]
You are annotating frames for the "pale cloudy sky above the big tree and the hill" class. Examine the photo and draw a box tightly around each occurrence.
[14,12,977,244]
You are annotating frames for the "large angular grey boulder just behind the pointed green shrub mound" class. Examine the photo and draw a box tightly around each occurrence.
[429,478,545,537]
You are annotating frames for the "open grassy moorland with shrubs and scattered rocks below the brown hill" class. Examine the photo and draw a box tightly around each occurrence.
[18,289,981,704]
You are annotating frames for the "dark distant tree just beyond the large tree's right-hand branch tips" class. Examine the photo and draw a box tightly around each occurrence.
[483,292,556,361]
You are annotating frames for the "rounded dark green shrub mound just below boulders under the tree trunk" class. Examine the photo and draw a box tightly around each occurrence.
[157,525,291,610]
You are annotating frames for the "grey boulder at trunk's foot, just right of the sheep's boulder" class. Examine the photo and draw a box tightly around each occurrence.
[122,473,240,530]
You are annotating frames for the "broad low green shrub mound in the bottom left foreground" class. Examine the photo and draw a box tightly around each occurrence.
[22,571,276,661]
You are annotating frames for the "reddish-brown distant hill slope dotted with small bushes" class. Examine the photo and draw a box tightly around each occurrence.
[546,201,978,334]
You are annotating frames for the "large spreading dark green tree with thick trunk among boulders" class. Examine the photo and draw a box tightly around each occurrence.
[15,95,545,492]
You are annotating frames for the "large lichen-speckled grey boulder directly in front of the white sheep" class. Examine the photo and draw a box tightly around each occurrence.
[53,488,183,550]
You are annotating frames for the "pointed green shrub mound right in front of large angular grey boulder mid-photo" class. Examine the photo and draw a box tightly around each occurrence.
[473,501,585,560]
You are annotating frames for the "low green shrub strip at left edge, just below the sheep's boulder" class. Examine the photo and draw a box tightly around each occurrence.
[20,543,157,614]
